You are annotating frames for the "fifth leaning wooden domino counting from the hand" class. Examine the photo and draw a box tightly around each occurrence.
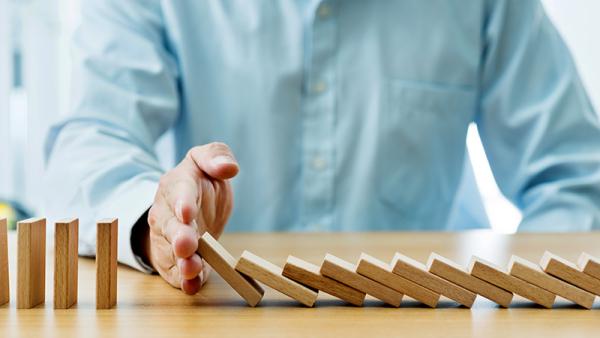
[356,253,440,307]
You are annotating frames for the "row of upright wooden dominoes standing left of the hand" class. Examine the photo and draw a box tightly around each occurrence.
[0,218,118,309]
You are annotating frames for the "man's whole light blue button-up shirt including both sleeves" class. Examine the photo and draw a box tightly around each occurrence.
[46,0,600,265]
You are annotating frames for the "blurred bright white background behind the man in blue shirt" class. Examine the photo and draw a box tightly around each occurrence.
[0,0,600,233]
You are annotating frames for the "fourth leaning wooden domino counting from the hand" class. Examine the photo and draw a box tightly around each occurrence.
[321,254,404,307]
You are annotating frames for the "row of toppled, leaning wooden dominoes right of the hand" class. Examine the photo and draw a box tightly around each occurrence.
[198,233,600,309]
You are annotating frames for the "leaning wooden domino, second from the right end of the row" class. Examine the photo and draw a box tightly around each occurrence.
[540,251,600,295]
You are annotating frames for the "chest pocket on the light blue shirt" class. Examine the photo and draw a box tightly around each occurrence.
[376,80,476,229]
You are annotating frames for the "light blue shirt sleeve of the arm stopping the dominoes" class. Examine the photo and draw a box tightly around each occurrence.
[45,0,179,271]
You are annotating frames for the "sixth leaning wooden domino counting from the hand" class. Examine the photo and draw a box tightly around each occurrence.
[391,253,477,308]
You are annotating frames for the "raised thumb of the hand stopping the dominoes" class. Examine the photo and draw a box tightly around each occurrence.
[186,142,239,180]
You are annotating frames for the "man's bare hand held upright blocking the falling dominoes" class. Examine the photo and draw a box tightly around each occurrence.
[146,143,239,294]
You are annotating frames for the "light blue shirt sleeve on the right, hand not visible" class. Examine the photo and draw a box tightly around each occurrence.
[476,0,600,231]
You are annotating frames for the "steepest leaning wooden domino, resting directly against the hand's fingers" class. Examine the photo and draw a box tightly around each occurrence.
[198,232,265,306]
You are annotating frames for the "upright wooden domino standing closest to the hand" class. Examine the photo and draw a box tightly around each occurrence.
[96,218,119,309]
